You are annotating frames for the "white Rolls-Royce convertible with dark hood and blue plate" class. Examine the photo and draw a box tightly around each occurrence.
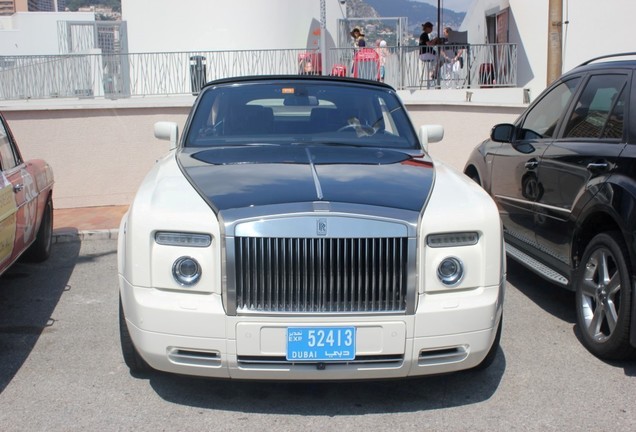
[118,76,505,380]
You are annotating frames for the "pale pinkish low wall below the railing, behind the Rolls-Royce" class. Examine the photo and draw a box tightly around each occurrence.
[3,101,523,208]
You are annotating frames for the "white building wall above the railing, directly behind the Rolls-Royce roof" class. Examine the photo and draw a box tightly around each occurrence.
[122,0,345,53]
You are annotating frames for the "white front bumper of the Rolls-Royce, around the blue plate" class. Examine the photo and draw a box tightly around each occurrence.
[120,275,505,380]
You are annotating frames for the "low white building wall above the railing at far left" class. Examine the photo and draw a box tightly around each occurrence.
[0,12,95,56]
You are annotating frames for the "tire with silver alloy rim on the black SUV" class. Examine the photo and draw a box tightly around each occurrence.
[575,232,635,360]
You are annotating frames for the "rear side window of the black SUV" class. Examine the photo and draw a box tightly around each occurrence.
[564,75,627,139]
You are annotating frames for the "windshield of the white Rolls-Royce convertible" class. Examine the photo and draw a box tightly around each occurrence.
[185,80,420,149]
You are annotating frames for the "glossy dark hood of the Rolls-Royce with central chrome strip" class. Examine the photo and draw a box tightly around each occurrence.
[177,145,434,212]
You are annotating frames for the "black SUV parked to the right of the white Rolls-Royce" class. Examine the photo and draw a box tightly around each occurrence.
[464,53,636,359]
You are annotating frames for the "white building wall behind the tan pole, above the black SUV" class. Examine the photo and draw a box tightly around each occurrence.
[461,0,636,99]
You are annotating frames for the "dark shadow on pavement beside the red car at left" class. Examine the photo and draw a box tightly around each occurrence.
[0,241,81,393]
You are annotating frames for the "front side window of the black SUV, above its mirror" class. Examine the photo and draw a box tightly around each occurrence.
[518,78,581,140]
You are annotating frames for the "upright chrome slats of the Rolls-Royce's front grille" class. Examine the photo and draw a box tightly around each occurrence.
[235,237,408,313]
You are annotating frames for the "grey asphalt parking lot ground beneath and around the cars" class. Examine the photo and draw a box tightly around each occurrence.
[0,240,636,431]
